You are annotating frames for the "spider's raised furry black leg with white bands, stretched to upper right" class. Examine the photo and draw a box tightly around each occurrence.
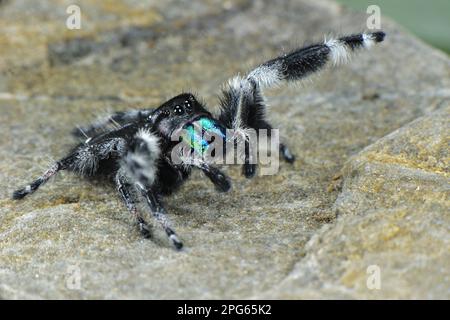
[219,31,385,177]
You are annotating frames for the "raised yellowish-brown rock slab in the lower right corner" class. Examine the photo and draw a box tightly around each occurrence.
[263,102,450,299]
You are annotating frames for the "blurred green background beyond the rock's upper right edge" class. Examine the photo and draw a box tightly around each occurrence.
[338,0,450,53]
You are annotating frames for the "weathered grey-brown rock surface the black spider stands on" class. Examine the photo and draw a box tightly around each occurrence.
[0,0,450,299]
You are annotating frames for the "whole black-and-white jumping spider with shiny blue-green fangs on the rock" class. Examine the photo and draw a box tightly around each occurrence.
[13,32,385,249]
